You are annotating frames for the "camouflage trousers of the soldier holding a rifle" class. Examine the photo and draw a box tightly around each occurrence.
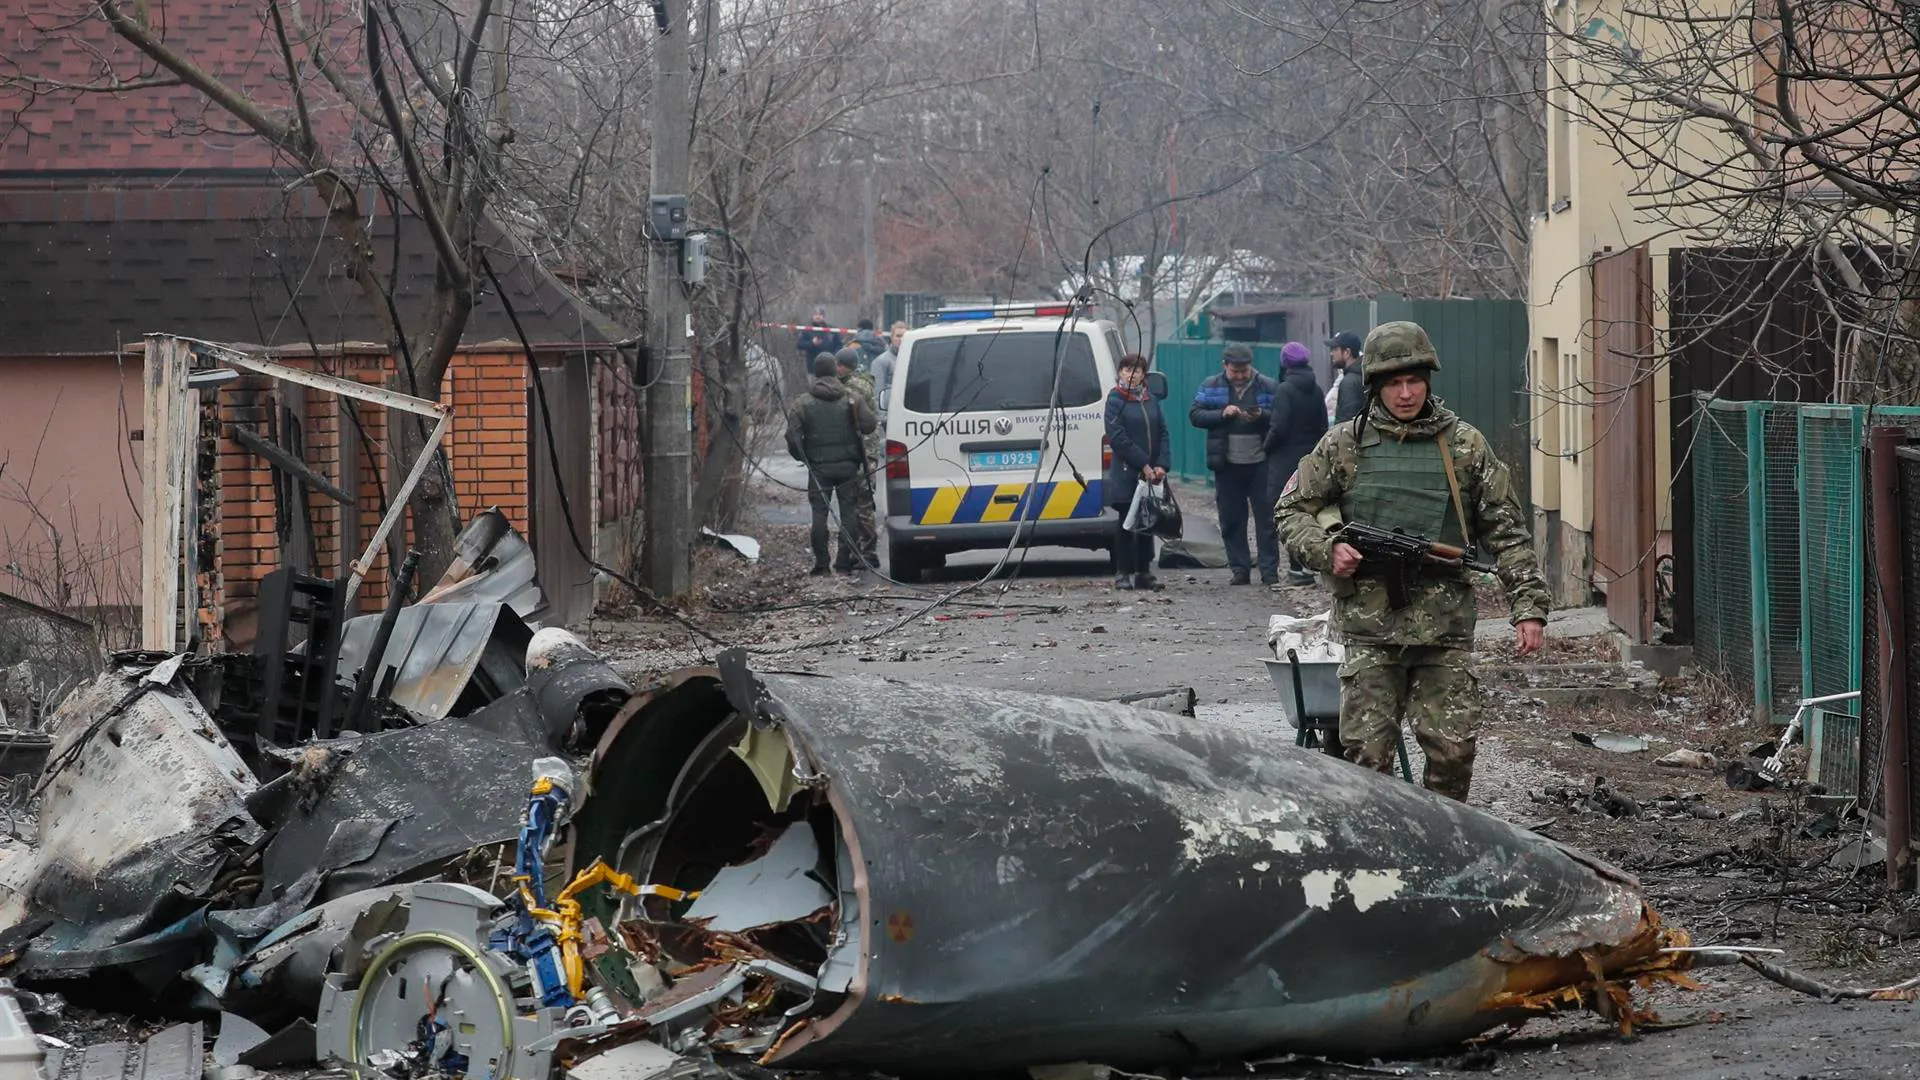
[1340,644,1480,801]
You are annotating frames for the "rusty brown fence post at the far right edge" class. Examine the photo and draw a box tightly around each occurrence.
[1862,427,1914,892]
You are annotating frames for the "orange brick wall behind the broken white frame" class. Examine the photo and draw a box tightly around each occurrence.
[219,354,530,634]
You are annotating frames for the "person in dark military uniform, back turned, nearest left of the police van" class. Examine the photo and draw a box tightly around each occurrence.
[787,354,877,577]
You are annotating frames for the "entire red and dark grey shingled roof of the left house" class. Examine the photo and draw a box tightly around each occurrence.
[0,0,630,356]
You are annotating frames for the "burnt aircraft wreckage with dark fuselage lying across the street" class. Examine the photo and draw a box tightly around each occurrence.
[0,590,1692,1080]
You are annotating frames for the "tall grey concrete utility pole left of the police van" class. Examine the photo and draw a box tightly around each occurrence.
[639,0,693,600]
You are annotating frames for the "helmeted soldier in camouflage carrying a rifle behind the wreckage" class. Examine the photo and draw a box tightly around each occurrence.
[1275,323,1548,801]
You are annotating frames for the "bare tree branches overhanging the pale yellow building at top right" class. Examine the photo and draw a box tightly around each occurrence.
[1553,0,1920,404]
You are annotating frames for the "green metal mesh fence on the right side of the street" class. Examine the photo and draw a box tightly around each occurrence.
[1676,394,1920,794]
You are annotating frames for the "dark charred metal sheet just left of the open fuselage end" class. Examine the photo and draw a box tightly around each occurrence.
[263,690,551,901]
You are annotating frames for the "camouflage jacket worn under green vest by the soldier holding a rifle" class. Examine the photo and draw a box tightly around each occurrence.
[1273,400,1549,648]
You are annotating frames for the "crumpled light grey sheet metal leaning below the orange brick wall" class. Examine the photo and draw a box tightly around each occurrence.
[338,601,534,721]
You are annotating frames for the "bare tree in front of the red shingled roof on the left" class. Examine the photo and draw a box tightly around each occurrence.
[0,0,513,580]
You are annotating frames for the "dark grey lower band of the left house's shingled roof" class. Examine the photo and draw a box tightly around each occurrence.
[0,188,626,356]
